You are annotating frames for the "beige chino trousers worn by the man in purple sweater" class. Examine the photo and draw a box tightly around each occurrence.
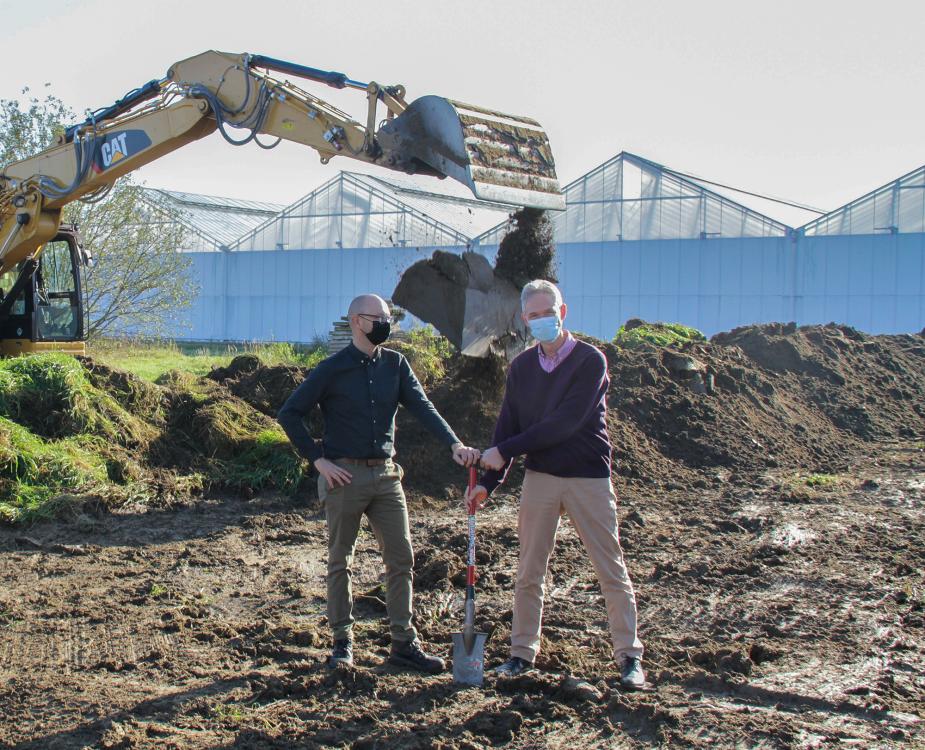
[511,470,643,662]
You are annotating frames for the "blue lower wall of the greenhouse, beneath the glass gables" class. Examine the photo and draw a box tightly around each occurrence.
[175,234,925,342]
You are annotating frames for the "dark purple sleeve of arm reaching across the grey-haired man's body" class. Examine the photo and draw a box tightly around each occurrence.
[495,352,608,459]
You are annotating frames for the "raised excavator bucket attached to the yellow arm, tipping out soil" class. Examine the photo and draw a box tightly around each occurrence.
[376,96,565,210]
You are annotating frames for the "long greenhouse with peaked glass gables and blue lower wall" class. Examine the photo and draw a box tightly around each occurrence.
[149,152,925,342]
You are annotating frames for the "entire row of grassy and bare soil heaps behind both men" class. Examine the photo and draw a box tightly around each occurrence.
[0,322,925,521]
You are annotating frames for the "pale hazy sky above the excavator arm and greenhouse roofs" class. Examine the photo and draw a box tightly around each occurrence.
[0,0,925,225]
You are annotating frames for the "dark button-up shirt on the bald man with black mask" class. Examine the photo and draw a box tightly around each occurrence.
[277,344,460,461]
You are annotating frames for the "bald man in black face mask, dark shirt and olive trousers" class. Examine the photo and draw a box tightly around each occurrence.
[277,294,479,673]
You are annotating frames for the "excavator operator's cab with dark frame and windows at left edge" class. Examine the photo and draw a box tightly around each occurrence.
[0,225,88,356]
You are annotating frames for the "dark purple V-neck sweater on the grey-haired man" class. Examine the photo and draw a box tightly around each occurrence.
[479,341,610,493]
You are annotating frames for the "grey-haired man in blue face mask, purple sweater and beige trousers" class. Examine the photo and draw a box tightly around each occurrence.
[466,280,645,689]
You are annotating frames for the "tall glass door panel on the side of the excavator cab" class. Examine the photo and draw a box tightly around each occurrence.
[35,242,80,341]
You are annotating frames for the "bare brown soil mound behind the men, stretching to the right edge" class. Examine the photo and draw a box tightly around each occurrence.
[212,321,925,500]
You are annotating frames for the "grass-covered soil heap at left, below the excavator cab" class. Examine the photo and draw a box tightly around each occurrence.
[0,354,307,522]
